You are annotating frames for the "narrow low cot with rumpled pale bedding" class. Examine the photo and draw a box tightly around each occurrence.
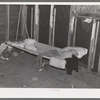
[6,39,87,73]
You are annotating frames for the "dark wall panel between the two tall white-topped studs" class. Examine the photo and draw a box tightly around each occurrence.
[39,5,50,44]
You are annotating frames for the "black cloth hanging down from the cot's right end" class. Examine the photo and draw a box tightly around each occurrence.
[65,55,79,75]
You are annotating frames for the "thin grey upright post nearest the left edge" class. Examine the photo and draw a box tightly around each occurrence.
[6,5,10,41]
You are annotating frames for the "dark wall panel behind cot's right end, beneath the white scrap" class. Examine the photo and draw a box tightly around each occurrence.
[75,18,93,67]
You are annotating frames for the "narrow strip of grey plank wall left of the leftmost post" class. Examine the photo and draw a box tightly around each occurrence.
[0,5,7,43]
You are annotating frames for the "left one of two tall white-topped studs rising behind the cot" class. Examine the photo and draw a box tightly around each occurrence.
[34,5,39,41]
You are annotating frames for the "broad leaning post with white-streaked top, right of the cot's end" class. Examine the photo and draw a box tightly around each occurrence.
[88,19,96,71]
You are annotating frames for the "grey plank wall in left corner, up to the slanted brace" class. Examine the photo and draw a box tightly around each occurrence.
[0,5,20,44]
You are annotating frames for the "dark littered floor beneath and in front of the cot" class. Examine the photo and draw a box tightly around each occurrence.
[0,49,100,88]
